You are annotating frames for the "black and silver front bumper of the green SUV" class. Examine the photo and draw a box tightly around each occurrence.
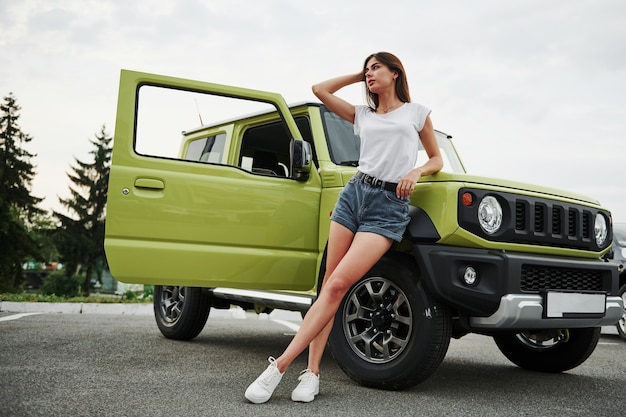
[413,244,624,329]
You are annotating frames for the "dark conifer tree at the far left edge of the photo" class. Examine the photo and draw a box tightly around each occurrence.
[0,93,44,292]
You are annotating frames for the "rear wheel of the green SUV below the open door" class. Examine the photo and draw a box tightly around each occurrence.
[154,285,211,340]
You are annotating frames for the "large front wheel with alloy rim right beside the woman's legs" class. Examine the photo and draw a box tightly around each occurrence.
[329,257,452,390]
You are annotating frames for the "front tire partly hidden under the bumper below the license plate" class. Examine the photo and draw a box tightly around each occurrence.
[493,327,601,373]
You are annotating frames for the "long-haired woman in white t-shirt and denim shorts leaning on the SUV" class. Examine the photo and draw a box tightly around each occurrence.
[245,52,443,404]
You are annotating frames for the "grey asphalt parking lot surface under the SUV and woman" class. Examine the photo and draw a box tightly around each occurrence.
[0,312,626,417]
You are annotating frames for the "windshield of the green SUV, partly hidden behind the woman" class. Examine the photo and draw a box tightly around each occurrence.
[320,106,465,173]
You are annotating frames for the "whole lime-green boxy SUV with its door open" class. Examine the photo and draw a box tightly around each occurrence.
[105,70,624,389]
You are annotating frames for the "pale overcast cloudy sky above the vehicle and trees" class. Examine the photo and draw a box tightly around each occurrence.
[0,0,626,222]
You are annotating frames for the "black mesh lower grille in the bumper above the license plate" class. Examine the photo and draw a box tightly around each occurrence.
[521,265,604,292]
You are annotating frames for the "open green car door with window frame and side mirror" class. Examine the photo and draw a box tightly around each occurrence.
[105,70,321,290]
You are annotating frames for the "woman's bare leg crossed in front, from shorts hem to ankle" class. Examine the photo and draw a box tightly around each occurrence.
[276,232,392,373]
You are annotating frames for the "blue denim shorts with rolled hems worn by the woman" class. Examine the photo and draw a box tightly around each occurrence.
[330,176,409,242]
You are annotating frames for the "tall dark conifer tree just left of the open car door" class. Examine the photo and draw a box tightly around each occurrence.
[54,125,112,294]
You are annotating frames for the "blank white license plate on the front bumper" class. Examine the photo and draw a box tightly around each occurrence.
[544,291,606,318]
